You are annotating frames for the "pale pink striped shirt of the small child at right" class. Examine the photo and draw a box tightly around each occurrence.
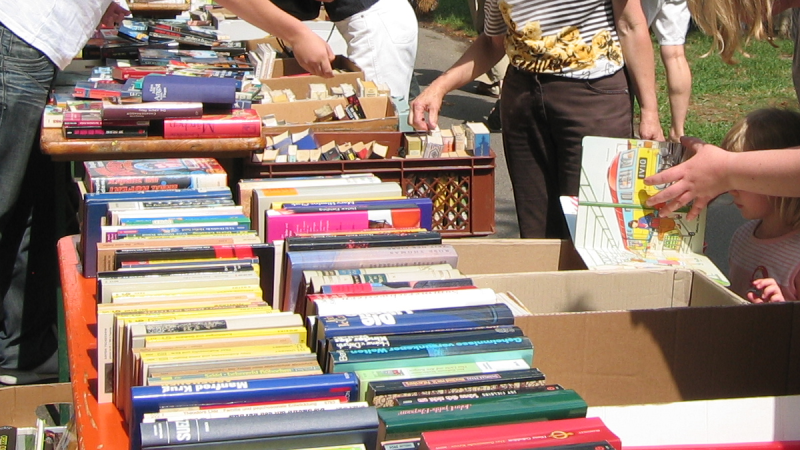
[728,220,800,300]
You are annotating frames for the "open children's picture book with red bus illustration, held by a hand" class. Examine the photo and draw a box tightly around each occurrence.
[574,136,729,286]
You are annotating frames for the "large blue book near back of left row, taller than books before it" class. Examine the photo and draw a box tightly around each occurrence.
[81,187,233,278]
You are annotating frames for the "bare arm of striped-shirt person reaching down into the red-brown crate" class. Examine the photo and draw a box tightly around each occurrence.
[409,33,505,130]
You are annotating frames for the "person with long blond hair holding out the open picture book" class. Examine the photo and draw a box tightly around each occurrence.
[645,0,800,219]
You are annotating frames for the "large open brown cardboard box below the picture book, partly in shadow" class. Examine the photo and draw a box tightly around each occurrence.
[448,239,800,406]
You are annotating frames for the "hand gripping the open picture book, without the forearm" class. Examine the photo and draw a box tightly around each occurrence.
[644,137,732,220]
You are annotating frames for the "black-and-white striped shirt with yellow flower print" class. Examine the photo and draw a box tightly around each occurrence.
[484,0,623,79]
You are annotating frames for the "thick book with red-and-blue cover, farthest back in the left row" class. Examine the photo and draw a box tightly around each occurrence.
[83,158,228,192]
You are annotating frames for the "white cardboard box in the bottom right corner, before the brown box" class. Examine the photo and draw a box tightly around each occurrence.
[587,395,800,449]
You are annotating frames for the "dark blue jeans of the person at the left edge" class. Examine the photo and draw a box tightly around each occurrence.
[0,24,58,370]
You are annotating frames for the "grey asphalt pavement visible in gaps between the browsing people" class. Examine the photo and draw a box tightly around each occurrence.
[415,27,744,273]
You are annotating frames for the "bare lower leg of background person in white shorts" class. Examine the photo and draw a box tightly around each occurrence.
[661,45,692,142]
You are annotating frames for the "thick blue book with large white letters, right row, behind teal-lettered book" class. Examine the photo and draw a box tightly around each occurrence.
[317,304,514,339]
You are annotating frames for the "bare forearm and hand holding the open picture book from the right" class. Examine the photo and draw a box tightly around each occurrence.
[645,137,800,220]
